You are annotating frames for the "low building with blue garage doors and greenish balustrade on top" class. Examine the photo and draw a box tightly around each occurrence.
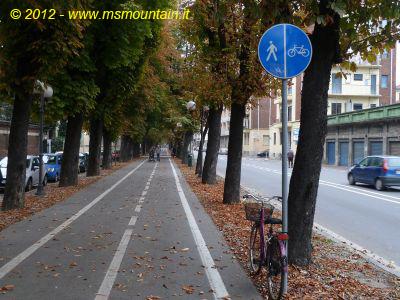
[324,103,400,166]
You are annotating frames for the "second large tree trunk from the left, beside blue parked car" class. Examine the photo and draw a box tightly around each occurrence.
[59,114,83,186]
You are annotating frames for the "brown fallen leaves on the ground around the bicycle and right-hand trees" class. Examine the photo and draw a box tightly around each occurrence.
[175,160,400,300]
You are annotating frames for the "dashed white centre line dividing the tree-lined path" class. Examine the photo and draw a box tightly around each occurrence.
[94,163,158,300]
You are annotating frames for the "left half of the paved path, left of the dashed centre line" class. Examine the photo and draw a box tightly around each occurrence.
[0,163,150,299]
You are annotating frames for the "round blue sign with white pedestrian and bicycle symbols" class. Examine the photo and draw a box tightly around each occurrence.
[258,24,312,79]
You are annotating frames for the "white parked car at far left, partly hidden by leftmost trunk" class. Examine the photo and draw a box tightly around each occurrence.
[0,155,48,191]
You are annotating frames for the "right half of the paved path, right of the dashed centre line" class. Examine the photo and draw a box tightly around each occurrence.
[104,159,261,300]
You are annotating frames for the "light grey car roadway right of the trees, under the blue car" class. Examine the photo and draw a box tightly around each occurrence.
[217,155,400,266]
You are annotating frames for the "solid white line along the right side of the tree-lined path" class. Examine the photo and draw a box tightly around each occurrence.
[169,159,229,299]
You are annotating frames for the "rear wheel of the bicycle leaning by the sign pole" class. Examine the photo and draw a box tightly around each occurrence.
[267,237,285,300]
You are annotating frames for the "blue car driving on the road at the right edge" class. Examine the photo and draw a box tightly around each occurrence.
[347,156,400,191]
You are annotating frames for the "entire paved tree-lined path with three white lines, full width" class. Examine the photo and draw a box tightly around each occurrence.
[0,158,260,300]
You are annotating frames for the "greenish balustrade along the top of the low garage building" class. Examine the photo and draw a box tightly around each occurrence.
[328,103,400,126]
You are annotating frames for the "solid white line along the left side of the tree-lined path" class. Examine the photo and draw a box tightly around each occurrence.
[0,161,146,279]
